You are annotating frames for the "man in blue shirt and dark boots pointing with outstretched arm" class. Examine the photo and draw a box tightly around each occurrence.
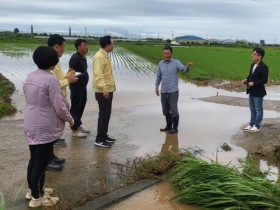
[155,46,192,134]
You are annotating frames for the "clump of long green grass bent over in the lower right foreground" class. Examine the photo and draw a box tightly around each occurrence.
[172,153,280,210]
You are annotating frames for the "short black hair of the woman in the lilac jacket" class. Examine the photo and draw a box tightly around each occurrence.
[33,46,59,70]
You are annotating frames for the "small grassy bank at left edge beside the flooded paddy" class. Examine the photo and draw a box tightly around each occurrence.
[0,73,16,118]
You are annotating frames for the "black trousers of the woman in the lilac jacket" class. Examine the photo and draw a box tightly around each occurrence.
[27,142,53,198]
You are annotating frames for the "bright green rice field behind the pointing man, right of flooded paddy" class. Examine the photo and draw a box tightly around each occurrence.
[121,43,280,83]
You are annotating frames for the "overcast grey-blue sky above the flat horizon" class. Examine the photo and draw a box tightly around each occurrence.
[0,0,280,43]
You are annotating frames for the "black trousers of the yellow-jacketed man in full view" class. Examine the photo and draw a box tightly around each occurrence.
[95,92,113,141]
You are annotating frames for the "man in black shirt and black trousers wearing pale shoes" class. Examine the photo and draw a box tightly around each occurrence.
[69,39,90,137]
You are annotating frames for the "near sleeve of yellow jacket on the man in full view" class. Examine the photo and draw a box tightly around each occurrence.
[93,57,106,92]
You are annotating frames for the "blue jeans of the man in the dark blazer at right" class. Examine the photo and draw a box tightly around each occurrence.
[249,94,263,128]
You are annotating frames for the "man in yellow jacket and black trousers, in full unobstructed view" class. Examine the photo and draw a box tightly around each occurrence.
[92,36,116,148]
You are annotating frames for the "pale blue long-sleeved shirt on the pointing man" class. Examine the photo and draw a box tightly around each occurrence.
[155,58,190,93]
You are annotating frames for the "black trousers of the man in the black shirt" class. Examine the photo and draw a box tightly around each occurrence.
[70,86,87,130]
